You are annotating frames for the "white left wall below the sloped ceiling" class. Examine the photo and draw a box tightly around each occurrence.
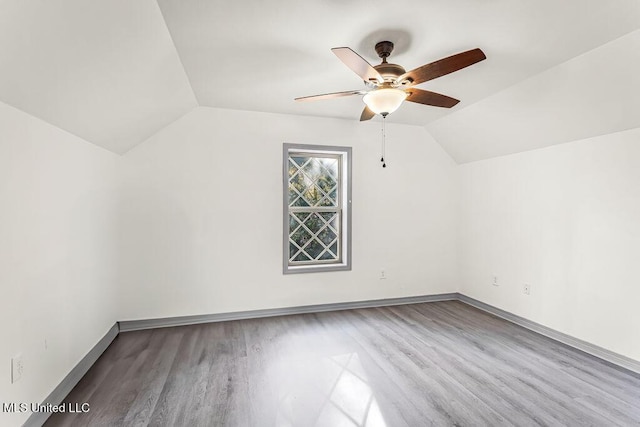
[0,103,117,425]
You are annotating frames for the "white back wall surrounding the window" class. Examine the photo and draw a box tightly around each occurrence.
[119,107,457,320]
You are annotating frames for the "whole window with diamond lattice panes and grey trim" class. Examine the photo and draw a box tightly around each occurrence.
[283,144,351,274]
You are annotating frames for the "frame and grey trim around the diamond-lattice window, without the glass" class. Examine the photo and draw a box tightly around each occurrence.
[282,143,351,274]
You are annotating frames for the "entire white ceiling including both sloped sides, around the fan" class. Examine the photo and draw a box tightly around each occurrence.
[0,0,640,162]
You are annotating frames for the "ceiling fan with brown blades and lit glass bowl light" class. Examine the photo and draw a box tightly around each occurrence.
[295,41,487,121]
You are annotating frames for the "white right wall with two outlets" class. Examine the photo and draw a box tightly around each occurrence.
[459,129,640,360]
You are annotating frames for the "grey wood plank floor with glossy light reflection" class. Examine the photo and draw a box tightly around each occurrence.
[46,301,640,427]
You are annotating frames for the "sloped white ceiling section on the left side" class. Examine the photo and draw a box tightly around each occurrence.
[0,0,197,153]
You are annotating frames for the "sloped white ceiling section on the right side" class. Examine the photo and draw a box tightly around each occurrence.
[427,30,640,163]
